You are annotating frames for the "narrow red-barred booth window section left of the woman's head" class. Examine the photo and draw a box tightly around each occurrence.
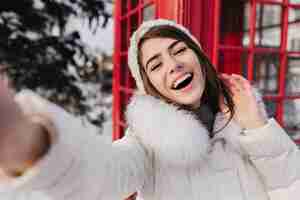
[113,0,156,140]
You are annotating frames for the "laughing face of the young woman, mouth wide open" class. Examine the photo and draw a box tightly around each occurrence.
[141,38,205,107]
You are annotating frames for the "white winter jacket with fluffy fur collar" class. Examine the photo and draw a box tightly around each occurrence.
[0,91,300,200]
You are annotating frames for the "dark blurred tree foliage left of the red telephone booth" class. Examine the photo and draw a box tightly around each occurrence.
[0,0,110,125]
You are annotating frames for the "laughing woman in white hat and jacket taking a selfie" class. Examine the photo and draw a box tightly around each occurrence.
[0,20,300,200]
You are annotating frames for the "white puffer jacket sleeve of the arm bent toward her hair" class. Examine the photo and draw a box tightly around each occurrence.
[240,119,300,200]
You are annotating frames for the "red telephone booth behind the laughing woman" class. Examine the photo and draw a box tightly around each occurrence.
[113,0,300,142]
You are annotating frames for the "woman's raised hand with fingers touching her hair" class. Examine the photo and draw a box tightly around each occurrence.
[220,74,267,129]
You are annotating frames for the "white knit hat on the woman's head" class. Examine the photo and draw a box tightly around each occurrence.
[128,19,201,94]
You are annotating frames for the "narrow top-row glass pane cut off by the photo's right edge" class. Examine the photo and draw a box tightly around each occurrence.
[288,8,300,51]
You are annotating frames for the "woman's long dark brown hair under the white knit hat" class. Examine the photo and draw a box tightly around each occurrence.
[138,25,234,137]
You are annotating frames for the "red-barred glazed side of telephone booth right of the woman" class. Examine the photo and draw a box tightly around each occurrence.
[212,0,300,144]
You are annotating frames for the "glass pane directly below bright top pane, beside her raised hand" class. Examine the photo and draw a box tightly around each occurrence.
[253,54,279,95]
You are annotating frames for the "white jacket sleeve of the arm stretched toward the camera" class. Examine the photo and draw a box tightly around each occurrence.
[0,91,150,200]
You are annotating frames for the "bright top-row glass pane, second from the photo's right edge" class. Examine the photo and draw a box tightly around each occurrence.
[255,4,282,48]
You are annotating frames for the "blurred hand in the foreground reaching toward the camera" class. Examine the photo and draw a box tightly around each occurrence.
[0,76,48,176]
